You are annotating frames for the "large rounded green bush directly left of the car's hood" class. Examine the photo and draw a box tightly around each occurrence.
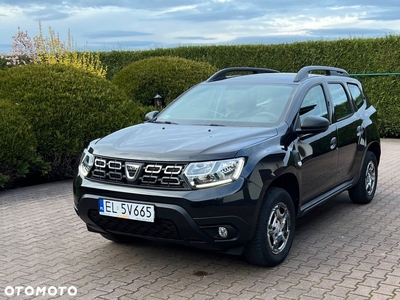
[0,64,143,179]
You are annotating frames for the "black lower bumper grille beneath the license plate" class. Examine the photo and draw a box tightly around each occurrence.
[89,210,180,240]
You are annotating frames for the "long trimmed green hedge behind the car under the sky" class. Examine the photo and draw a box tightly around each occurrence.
[100,35,400,137]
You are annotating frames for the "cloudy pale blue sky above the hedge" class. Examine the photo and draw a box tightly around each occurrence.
[0,0,400,54]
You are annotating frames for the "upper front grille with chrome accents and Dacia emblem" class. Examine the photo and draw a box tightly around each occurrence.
[89,156,189,189]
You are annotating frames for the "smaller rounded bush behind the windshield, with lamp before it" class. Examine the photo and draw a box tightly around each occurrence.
[112,56,217,105]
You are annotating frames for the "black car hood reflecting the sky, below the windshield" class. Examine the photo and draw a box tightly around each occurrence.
[93,123,277,161]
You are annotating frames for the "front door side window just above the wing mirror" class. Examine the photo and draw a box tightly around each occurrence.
[300,85,328,122]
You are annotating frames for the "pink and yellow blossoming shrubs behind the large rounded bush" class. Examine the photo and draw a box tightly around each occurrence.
[3,22,107,77]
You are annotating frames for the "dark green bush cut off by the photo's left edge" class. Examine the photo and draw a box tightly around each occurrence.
[0,100,49,188]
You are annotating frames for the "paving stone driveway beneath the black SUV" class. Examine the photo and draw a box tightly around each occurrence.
[0,139,400,300]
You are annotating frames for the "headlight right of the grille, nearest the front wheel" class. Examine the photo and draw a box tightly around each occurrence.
[184,157,244,188]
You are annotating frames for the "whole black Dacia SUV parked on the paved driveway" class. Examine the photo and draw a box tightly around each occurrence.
[74,66,381,266]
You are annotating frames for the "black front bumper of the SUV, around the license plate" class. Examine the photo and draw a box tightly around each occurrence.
[74,175,261,254]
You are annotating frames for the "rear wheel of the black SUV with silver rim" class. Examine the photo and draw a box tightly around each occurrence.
[349,151,378,204]
